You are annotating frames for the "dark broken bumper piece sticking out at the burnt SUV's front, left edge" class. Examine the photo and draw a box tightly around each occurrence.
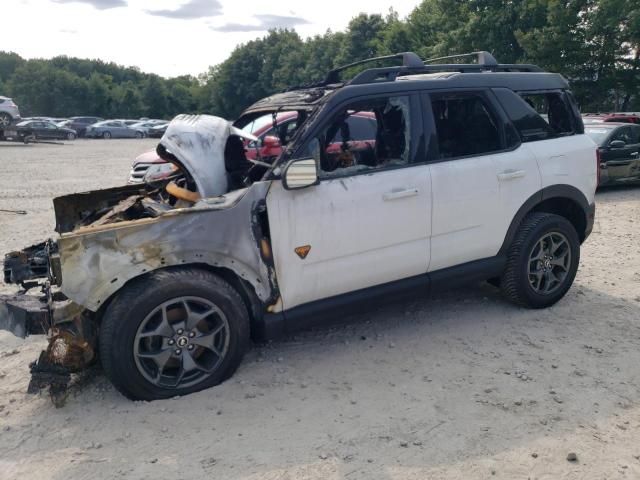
[0,294,50,338]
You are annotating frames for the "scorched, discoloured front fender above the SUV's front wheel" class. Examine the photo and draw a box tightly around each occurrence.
[58,182,277,312]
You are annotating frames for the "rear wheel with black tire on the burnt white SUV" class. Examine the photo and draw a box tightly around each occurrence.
[500,212,580,308]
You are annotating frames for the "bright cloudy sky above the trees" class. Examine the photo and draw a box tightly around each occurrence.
[7,0,420,77]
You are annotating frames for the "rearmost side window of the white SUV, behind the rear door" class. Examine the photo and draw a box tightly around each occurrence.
[494,88,576,142]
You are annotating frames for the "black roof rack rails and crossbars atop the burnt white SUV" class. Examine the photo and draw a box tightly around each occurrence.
[314,51,543,86]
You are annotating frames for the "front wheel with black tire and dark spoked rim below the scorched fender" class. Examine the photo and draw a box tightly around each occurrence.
[100,269,249,400]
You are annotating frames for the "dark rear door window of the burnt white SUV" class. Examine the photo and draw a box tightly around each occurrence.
[431,93,502,159]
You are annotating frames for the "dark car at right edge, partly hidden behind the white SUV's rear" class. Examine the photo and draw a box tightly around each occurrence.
[584,123,640,185]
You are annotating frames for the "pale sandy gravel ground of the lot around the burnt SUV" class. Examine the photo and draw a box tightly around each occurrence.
[0,140,640,480]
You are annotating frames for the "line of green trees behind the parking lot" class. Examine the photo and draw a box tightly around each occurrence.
[0,0,640,118]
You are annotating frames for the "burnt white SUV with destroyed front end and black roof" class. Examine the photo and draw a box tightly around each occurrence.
[0,52,598,399]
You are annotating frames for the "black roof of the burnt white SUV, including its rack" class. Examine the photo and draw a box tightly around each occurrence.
[245,51,569,113]
